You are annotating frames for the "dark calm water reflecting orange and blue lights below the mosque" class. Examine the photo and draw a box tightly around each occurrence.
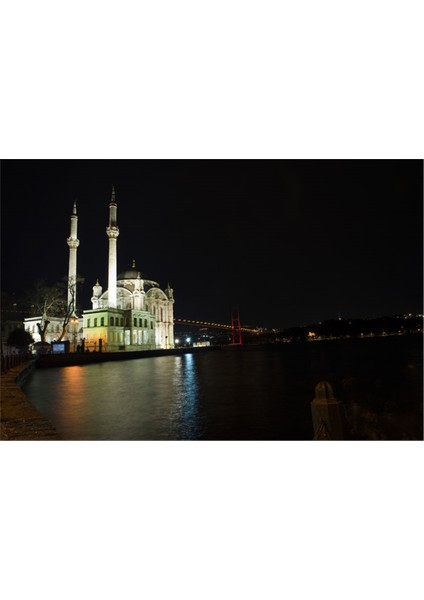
[23,336,423,440]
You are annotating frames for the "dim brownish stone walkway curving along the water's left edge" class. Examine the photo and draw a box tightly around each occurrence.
[0,363,62,441]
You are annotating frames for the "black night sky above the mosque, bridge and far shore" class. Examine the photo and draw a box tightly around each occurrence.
[1,159,423,328]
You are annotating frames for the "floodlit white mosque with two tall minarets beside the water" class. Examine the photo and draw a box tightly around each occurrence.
[25,187,174,352]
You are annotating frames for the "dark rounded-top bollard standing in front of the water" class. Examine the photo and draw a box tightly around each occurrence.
[311,381,344,440]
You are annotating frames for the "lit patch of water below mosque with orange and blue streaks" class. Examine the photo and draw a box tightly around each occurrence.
[24,354,204,440]
